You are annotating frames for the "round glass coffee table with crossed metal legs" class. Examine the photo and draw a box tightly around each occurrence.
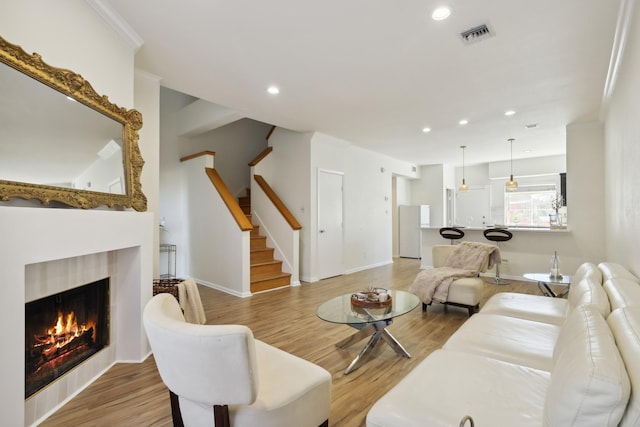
[317,290,420,375]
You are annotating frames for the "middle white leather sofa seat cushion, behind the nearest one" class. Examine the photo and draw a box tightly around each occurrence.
[442,312,560,371]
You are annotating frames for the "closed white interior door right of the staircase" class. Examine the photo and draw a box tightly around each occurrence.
[317,170,344,279]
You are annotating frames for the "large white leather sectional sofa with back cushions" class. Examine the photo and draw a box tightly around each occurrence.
[366,263,640,427]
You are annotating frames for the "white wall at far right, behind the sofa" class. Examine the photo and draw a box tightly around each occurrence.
[602,2,640,275]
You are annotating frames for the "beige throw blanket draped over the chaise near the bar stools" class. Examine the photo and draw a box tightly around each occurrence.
[409,242,501,304]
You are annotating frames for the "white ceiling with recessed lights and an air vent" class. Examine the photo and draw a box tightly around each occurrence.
[106,0,620,165]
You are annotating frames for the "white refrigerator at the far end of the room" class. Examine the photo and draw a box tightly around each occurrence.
[398,205,429,258]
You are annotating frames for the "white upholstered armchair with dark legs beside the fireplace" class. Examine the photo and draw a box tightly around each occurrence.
[143,293,331,427]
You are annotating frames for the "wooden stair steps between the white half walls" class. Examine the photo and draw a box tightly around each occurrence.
[238,190,291,292]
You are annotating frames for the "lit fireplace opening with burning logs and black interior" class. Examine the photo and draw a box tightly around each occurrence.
[25,278,109,398]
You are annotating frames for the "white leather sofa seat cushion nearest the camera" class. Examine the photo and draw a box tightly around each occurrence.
[366,350,550,427]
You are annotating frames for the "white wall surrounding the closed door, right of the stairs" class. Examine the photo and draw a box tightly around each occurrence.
[269,128,417,282]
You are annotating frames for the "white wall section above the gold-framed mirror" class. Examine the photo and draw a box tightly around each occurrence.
[0,0,134,108]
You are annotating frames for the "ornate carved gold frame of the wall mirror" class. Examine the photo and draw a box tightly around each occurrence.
[0,37,147,211]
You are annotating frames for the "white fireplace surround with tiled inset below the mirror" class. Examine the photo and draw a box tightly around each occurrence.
[0,207,154,426]
